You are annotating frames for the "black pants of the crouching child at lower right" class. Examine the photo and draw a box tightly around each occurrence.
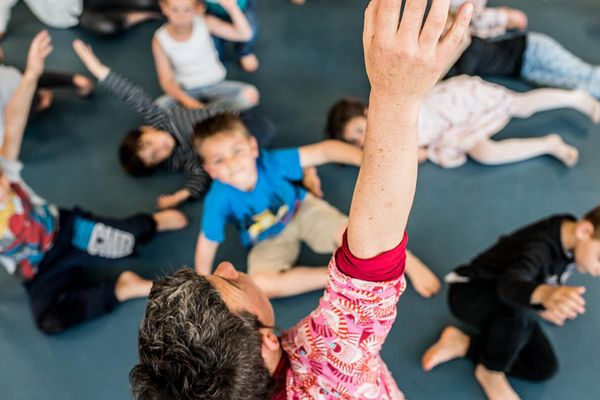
[448,282,558,381]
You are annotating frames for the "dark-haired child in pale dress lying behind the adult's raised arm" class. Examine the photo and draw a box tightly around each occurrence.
[326,75,600,168]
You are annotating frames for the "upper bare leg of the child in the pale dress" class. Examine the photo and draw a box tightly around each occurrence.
[515,89,600,124]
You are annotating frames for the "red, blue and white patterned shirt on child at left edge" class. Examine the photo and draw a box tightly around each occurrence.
[0,157,58,280]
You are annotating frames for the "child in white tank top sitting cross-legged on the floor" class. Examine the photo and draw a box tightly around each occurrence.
[152,0,259,111]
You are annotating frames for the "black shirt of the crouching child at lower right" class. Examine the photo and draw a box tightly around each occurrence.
[455,215,575,307]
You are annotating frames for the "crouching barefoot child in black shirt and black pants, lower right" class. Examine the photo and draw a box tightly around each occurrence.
[422,206,600,399]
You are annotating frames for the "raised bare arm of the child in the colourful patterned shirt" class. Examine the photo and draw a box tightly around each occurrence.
[0,31,52,161]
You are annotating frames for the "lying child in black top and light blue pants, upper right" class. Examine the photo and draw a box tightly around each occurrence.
[448,0,600,99]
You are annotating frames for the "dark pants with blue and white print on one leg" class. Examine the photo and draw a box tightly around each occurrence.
[25,209,156,334]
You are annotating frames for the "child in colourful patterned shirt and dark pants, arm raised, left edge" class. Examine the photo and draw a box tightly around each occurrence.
[0,31,187,334]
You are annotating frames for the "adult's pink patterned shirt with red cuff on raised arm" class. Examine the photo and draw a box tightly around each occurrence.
[282,236,407,400]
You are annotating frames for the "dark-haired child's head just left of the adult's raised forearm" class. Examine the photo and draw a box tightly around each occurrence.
[325,97,367,147]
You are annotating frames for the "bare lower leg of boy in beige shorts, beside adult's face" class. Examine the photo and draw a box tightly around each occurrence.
[251,267,328,298]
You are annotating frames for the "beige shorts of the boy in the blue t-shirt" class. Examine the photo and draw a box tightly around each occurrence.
[248,194,348,275]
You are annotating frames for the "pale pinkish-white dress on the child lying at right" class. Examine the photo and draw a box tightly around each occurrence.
[419,75,516,168]
